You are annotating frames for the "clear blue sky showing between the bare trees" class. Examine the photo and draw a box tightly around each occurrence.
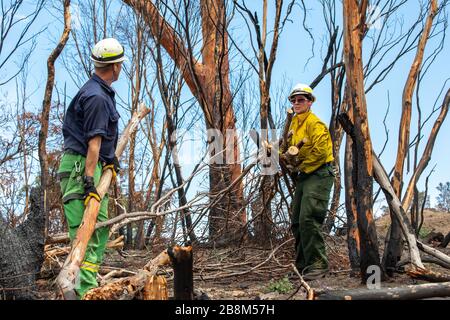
[0,0,450,212]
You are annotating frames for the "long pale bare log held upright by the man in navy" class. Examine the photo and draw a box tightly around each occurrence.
[56,106,150,300]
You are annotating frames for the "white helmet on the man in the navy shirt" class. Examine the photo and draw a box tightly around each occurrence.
[91,38,126,68]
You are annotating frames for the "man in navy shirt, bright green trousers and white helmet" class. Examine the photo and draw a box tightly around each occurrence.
[58,38,125,298]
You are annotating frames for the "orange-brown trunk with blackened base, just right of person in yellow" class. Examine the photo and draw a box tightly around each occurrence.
[343,0,380,281]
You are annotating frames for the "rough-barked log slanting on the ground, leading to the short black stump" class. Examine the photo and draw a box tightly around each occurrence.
[83,250,171,300]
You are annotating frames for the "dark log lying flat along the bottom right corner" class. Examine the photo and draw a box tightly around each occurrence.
[316,282,450,300]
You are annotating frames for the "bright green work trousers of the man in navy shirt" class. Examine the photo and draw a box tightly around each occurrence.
[58,153,109,298]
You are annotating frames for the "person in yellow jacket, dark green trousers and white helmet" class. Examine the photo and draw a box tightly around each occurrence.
[289,84,334,280]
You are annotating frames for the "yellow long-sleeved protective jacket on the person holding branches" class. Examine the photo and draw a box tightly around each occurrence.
[289,111,334,173]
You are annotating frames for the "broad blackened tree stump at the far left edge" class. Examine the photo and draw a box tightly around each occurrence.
[0,188,45,300]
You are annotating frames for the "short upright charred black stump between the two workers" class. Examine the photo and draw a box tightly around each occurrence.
[167,246,194,300]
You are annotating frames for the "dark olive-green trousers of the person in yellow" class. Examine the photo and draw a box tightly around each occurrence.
[292,166,334,272]
